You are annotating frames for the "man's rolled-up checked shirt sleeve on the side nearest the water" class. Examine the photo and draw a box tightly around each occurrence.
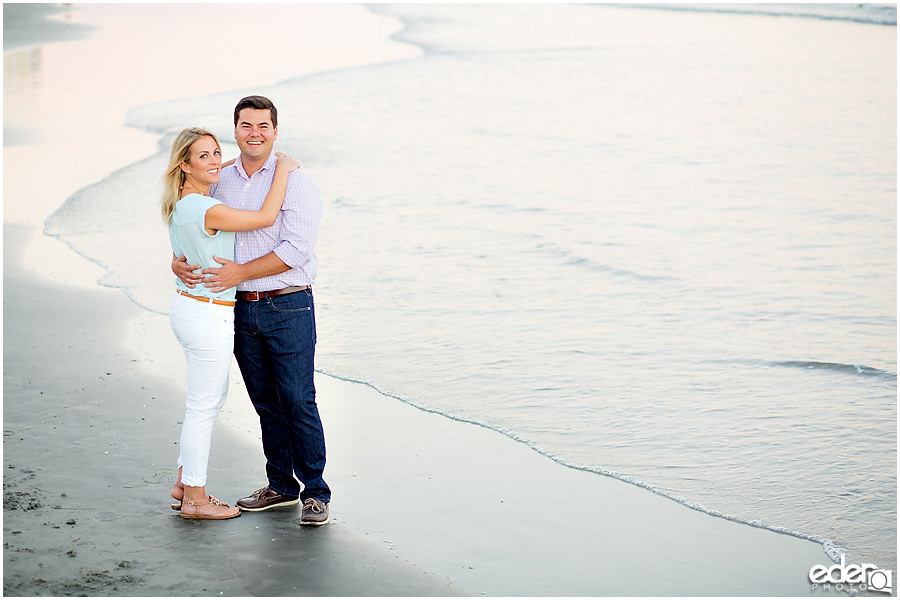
[274,170,322,269]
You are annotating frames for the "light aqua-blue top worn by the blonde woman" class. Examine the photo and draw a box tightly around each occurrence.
[169,194,236,302]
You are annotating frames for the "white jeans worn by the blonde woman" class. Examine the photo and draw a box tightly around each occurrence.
[169,293,234,487]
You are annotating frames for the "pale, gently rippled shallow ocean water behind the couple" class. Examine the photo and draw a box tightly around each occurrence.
[47,5,897,570]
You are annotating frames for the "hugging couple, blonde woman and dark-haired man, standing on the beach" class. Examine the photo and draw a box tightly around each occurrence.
[162,96,331,525]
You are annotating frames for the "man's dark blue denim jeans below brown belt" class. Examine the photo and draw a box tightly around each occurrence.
[234,290,331,502]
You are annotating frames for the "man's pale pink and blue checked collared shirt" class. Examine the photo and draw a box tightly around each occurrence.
[210,152,322,292]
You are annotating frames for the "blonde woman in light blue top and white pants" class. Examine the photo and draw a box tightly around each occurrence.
[162,128,300,519]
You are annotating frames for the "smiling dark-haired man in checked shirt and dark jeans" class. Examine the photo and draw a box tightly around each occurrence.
[172,96,331,525]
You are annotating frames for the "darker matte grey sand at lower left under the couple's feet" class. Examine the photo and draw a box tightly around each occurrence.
[3,225,460,596]
